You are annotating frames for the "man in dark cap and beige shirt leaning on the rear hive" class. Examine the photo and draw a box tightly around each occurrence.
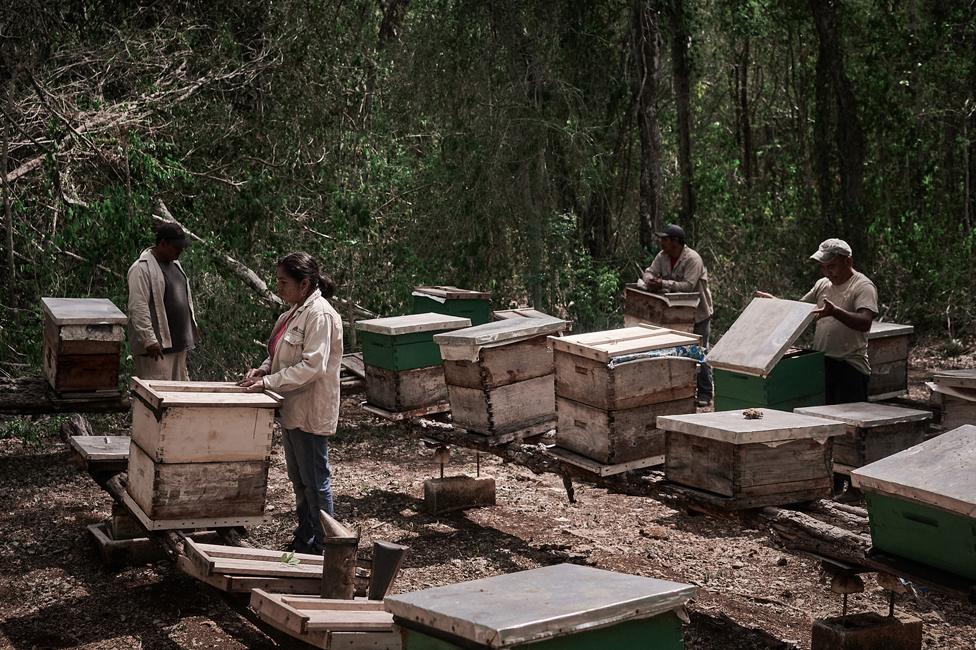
[641,223,714,406]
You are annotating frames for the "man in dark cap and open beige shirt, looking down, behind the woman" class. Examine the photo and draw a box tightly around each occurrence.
[128,222,198,381]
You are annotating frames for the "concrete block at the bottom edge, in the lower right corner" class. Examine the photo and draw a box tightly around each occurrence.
[810,612,922,650]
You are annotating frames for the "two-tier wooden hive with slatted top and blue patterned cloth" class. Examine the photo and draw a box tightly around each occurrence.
[550,325,699,465]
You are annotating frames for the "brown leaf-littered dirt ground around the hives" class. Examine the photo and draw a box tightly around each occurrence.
[0,342,976,650]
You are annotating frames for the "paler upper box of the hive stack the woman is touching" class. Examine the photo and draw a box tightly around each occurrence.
[132,377,281,463]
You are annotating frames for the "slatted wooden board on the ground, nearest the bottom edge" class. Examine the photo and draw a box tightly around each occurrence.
[251,589,402,650]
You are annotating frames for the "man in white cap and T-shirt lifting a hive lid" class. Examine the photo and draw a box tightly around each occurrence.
[756,239,878,404]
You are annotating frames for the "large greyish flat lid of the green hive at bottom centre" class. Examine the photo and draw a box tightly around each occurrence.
[384,564,695,648]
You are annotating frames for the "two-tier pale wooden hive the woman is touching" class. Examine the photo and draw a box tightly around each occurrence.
[126,377,281,530]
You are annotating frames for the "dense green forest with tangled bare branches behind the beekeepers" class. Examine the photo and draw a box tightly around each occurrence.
[0,0,976,378]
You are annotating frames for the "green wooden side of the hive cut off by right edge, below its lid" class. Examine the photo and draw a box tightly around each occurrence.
[864,491,976,580]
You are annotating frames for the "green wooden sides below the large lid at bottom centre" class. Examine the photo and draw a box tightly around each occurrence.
[401,612,684,650]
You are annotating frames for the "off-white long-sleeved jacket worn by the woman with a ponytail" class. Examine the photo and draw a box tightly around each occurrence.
[260,289,342,436]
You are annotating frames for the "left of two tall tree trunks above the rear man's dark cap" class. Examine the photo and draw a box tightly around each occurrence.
[634,0,663,251]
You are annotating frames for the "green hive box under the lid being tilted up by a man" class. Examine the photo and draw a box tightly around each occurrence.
[713,351,825,411]
